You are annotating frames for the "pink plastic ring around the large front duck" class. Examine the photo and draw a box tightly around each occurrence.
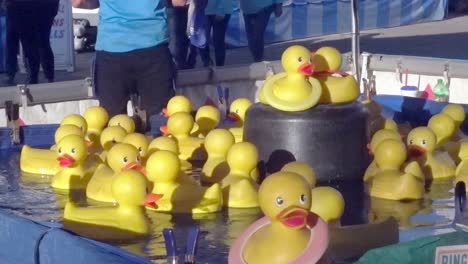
[228,213,329,264]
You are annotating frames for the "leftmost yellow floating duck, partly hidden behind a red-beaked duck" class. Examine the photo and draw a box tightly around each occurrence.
[20,125,83,176]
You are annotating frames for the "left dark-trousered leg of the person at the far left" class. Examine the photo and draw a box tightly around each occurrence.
[14,2,40,84]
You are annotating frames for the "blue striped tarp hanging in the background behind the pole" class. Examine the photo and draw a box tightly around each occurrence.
[226,0,448,47]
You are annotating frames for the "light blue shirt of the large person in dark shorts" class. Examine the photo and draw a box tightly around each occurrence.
[96,0,169,52]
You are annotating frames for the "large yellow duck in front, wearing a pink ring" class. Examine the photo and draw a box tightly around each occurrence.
[228,172,329,264]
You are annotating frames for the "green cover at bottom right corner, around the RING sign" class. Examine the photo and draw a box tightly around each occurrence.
[356,232,468,264]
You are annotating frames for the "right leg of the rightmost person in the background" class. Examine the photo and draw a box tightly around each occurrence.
[247,6,274,62]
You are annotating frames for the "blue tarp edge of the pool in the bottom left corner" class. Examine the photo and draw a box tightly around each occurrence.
[0,210,151,264]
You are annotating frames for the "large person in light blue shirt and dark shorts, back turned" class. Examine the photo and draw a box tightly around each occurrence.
[71,0,186,131]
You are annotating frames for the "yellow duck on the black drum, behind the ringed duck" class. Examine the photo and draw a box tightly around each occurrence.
[312,47,360,104]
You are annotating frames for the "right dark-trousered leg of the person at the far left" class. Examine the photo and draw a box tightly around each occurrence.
[37,1,59,82]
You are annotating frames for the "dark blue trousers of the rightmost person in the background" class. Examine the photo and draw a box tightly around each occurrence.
[244,5,274,62]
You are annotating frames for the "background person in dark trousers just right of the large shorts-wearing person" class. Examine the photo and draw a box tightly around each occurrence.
[200,0,233,67]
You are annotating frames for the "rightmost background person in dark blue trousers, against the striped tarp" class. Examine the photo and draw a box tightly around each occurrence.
[239,0,283,62]
